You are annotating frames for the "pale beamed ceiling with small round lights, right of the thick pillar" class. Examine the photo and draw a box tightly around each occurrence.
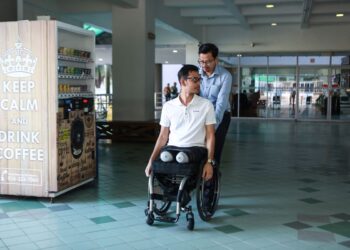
[164,0,350,29]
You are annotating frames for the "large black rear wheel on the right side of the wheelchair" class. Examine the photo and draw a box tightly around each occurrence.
[196,168,220,221]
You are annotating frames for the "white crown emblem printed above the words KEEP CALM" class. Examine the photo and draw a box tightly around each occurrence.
[0,41,38,77]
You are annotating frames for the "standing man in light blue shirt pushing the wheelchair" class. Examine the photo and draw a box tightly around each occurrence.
[198,43,232,165]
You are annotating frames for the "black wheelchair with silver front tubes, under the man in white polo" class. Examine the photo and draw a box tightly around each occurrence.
[145,160,221,230]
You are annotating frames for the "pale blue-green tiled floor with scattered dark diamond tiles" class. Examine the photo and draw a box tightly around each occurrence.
[0,120,350,250]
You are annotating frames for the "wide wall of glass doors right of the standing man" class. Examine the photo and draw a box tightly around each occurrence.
[227,55,350,120]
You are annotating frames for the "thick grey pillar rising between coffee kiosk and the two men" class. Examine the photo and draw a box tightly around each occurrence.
[112,1,155,121]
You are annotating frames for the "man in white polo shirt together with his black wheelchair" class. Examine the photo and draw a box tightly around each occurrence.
[145,65,219,230]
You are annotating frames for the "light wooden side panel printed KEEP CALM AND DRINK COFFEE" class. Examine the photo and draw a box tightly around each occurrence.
[0,21,56,196]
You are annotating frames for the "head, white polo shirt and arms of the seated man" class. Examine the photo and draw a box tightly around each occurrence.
[145,65,216,180]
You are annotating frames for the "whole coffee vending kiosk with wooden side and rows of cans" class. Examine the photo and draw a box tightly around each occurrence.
[0,20,96,198]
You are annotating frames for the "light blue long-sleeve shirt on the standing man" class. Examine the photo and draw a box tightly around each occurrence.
[200,65,232,128]
